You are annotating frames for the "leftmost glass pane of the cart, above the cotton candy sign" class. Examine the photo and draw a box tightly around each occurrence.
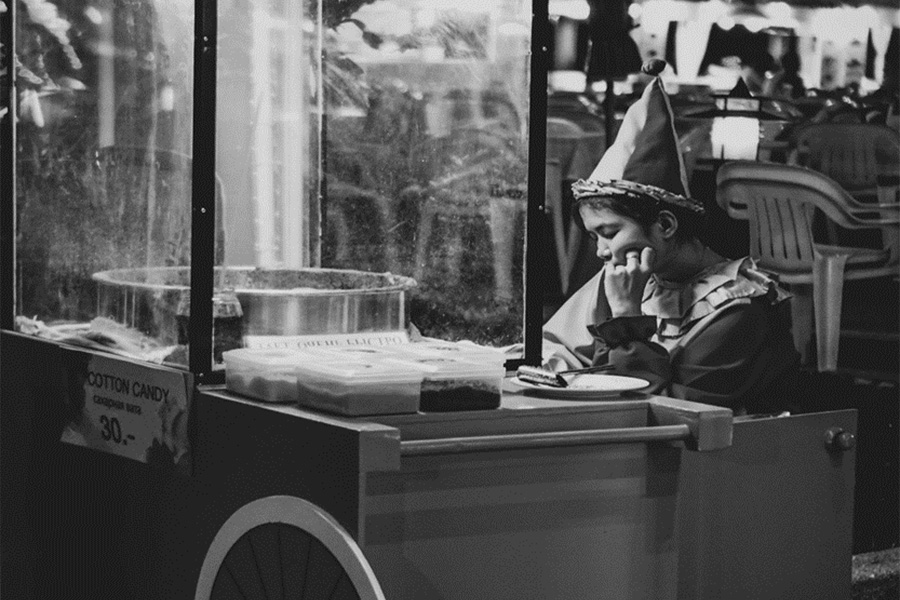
[15,0,194,364]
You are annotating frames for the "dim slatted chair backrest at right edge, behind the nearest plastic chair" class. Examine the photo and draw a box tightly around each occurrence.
[791,123,900,192]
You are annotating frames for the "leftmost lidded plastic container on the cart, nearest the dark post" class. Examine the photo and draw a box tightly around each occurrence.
[222,348,314,402]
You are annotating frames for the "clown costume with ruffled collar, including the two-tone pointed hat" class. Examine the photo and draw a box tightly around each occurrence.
[543,61,798,413]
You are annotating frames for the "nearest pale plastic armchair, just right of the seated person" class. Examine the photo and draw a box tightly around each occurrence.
[717,161,900,371]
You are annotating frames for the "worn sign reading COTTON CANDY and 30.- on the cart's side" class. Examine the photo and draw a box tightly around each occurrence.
[62,350,190,465]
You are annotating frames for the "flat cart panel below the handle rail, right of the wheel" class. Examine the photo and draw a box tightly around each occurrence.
[365,444,682,600]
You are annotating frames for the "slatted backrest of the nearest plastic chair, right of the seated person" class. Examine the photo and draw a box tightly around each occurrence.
[716,161,854,281]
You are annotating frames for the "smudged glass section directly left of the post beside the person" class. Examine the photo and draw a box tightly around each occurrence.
[321,0,531,346]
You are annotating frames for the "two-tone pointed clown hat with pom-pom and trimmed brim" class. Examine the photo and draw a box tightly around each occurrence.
[572,59,703,212]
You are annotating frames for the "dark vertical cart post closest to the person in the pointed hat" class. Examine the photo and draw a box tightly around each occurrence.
[524,0,550,365]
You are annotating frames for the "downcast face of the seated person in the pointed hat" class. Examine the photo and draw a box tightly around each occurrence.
[579,206,662,265]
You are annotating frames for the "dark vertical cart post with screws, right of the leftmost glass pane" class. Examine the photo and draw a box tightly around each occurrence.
[188,0,218,384]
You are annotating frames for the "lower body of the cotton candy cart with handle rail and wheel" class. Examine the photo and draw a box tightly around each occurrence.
[0,331,856,600]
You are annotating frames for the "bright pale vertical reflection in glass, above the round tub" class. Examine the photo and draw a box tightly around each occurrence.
[216,0,319,268]
